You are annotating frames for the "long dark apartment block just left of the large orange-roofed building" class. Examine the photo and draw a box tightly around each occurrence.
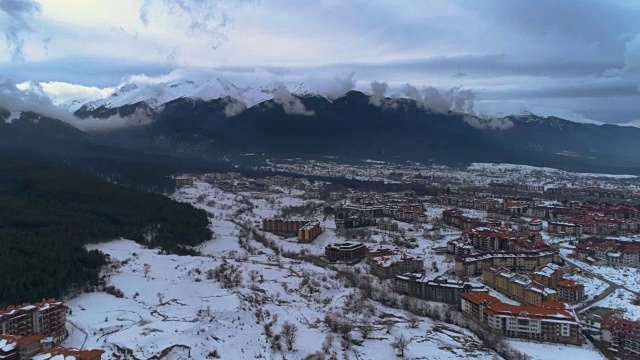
[394,273,485,305]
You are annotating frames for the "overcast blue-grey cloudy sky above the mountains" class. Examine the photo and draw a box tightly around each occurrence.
[0,0,640,123]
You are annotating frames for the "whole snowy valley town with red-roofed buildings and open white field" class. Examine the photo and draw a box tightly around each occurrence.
[13,164,640,359]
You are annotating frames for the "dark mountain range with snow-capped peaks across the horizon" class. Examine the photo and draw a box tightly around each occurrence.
[0,78,640,174]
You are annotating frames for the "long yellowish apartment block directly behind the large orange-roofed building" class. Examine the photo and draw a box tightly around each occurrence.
[482,267,558,306]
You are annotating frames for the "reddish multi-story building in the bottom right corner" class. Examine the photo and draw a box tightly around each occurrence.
[600,318,640,360]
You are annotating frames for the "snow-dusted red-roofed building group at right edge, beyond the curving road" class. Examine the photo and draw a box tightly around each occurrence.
[573,237,640,268]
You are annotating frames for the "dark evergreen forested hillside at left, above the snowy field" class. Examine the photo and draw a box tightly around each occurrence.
[0,157,211,306]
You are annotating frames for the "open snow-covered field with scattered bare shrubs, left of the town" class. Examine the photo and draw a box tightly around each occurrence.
[64,183,504,360]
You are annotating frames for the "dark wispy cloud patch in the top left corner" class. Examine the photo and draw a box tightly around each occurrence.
[0,0,42,62]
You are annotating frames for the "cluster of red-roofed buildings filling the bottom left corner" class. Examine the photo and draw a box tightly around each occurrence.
[0,300,104,360]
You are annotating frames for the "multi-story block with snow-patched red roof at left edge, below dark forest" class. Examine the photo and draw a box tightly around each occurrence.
[0,300,67,344]
